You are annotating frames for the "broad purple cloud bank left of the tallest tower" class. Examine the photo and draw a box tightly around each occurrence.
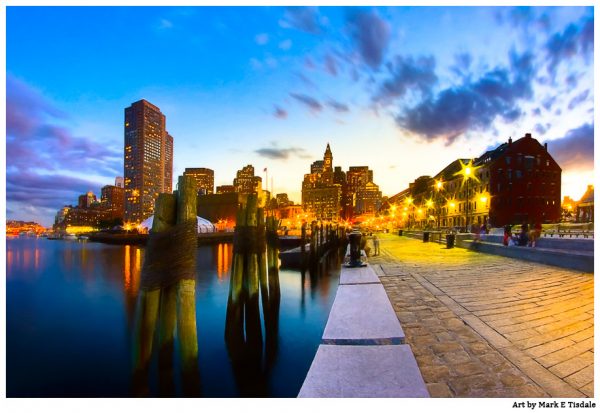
[6,74,123,220]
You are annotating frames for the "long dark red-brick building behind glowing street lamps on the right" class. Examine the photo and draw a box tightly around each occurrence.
[390,133,561,228]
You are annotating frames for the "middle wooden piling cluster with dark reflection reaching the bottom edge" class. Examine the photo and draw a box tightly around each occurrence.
[225,195,281,397]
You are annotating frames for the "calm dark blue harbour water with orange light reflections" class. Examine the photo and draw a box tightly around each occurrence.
[6,238,339,397]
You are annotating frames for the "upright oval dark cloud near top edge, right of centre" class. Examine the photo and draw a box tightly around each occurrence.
[348,11,391,69]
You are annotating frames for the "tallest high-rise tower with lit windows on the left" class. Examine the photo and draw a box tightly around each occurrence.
[124,99,173,223]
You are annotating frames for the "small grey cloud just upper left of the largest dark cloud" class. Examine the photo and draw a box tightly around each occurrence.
[373,56,437,104]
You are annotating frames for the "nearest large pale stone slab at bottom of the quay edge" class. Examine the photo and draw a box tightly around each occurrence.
[298,344,429,397]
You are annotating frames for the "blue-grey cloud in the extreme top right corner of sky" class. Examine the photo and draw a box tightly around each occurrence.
[545,15,594,78]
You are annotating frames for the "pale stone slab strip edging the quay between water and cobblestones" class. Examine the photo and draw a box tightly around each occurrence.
[298,265,429,398]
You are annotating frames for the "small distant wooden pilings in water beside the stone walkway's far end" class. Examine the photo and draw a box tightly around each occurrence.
[300,221,346,267]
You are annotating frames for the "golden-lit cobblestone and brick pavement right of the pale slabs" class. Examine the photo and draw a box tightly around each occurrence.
[369,234,594,397]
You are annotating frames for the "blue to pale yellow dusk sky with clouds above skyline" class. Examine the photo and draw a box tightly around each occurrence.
[6,6,594,226]
